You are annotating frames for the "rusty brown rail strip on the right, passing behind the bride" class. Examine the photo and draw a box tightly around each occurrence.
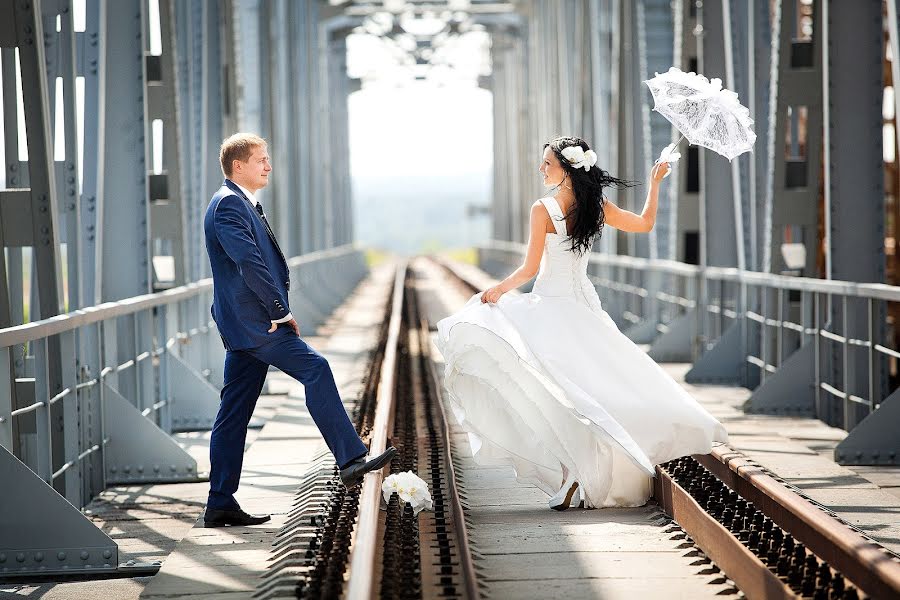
[430,254,900,600]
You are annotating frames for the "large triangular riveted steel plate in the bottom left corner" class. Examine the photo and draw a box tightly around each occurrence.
[0,447,119,577]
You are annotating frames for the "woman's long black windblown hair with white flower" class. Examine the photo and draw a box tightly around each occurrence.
[542,137,637,254]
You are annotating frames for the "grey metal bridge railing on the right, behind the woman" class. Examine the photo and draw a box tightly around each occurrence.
[478,242,900,463]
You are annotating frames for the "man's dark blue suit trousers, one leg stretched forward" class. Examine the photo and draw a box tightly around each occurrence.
[207,327,367,510]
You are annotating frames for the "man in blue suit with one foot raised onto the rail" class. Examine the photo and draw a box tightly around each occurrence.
[203,133,397,527]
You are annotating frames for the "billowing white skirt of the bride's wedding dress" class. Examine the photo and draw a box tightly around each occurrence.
[436,293,728,507]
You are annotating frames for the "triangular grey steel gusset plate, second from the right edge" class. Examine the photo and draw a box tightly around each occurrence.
[744,344,816,417]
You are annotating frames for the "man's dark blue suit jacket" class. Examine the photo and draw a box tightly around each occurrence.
[203,179,291,350]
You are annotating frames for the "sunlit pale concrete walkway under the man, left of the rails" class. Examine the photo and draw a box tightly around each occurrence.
[0,266,393,600]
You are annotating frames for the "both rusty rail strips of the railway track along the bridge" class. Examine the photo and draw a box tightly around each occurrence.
[256,255,900,600]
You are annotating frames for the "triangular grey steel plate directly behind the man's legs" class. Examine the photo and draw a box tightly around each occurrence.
[166,352,219,431]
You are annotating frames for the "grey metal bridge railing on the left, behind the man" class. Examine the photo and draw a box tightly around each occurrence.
[0,246,366,507]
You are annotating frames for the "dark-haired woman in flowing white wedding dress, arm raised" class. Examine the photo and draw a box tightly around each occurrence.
[437,137,728,510]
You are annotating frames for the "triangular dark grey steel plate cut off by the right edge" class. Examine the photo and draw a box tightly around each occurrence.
[834,389,900,465]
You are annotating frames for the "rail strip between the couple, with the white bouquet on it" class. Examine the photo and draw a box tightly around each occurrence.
[255,264,477,599]
